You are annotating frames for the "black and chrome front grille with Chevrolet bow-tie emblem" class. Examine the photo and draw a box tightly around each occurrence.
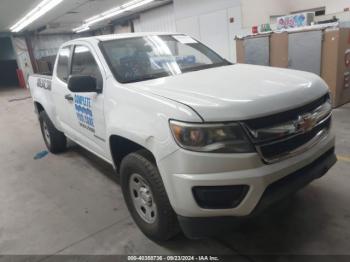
[243,95,332,164]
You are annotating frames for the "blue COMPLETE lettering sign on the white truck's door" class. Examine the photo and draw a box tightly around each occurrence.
[74,95,95,133]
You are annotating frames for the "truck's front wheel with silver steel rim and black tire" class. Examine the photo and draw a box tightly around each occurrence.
[121,151,180,241]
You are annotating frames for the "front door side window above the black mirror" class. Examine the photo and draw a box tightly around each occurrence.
[72,46,103,88]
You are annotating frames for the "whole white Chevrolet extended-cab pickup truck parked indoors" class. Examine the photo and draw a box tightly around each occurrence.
[29,33,336,241]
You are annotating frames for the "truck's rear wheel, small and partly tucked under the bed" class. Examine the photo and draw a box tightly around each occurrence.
[39,111,67,154]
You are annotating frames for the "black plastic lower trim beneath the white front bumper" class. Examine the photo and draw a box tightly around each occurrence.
[178,148,337,238]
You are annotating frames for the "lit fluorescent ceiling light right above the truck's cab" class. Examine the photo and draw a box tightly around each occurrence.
[73,0,155,33]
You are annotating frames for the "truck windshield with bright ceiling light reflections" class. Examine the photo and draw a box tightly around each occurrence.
[101,35,230,83]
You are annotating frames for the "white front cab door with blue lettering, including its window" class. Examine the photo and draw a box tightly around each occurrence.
[53,44,107,157]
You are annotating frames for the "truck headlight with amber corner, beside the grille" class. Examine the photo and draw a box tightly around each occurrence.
[170,120,254,153]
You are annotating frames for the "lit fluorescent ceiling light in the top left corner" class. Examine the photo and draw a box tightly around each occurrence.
[10,0,63,33]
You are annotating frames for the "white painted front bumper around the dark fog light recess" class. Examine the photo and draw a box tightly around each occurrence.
[158,132,335,218]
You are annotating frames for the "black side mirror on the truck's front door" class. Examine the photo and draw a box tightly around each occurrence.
[68,75,99,93]
